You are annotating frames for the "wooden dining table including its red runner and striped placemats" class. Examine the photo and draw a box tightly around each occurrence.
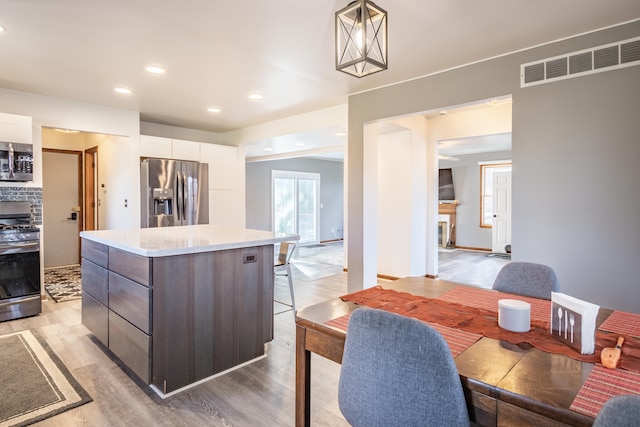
[295,277,640,426]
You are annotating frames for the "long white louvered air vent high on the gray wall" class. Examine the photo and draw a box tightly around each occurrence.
[520,37,640,87]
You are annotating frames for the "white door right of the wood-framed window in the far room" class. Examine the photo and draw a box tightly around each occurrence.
[491,171,511,253]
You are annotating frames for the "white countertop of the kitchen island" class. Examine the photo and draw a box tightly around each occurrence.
[80,224,300,258]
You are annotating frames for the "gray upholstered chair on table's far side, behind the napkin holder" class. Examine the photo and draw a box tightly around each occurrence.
[493,262,560,300]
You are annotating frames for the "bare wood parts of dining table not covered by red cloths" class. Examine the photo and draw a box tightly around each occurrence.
[295,277,612,427]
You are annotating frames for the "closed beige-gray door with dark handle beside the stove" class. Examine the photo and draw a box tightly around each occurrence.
[42,149,82,268]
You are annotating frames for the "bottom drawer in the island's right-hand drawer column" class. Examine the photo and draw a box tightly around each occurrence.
[109,310,151,384]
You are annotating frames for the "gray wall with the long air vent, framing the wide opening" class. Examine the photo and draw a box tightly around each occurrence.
[347,21,640,313]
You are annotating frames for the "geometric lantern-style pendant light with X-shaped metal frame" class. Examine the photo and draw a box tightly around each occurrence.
[336,0,387,77]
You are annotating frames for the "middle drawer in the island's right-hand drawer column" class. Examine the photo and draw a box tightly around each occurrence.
[109,272,151,334]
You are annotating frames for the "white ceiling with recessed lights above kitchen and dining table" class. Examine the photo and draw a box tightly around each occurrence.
[0,0,640,158]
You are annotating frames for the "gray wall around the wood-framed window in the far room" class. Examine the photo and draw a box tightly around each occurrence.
[439,151,511,250]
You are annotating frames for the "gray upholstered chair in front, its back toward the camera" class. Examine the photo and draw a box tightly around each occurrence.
[338,308,469,427]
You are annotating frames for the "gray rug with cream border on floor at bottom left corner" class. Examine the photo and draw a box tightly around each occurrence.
[0,330,92,427]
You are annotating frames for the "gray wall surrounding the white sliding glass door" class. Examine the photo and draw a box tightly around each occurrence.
[245,158,344,241]
